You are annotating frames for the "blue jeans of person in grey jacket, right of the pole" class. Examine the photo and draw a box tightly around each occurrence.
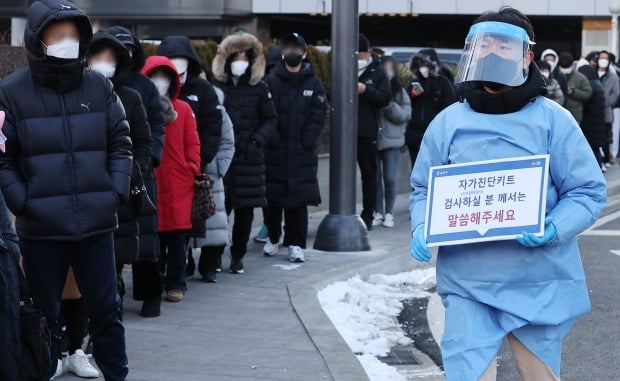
[375,148,400,215]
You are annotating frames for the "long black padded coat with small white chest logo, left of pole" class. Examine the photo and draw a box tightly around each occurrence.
[265,62,327,209]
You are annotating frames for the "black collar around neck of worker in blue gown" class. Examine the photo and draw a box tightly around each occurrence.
[459,62,547,114]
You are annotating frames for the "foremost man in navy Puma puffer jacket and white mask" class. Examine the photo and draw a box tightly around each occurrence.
[0,0,132,380]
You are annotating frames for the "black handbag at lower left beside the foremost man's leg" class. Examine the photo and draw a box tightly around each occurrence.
[18,268,56,381]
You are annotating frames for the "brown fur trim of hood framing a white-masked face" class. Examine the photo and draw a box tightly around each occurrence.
[212,33,265,86]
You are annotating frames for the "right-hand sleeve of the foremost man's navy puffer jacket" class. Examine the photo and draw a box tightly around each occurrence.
[106,81,133,202]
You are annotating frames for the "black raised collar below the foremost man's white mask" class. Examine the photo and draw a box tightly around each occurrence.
[28,54,84,93]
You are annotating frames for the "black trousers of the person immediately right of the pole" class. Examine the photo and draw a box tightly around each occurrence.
[357,137,378,227]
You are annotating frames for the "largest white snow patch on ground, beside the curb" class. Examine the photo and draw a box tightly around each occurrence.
[318,268,435,381]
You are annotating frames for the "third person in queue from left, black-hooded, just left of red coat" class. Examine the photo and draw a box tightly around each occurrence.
[105,26,165,316]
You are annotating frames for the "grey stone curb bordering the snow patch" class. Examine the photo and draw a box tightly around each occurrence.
[287,246,422,381]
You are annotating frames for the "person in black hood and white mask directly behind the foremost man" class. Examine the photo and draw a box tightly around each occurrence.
[88,32,160,317]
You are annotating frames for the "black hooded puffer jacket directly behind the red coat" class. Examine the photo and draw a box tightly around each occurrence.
[157,36,222,167]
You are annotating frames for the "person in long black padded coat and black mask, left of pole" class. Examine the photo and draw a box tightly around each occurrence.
[263,33,327,262]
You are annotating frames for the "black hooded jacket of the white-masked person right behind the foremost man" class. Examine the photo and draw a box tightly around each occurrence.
[88,32,153,263]
